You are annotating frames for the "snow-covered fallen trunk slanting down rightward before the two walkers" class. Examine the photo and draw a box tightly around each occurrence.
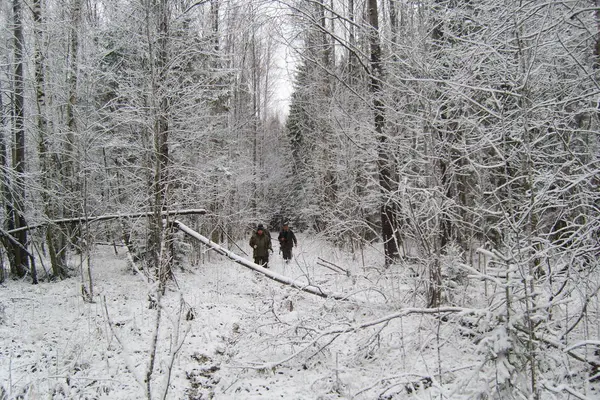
[173,220,347,300]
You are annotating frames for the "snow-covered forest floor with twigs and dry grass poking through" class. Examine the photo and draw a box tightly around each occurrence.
[0,235,596,400]
